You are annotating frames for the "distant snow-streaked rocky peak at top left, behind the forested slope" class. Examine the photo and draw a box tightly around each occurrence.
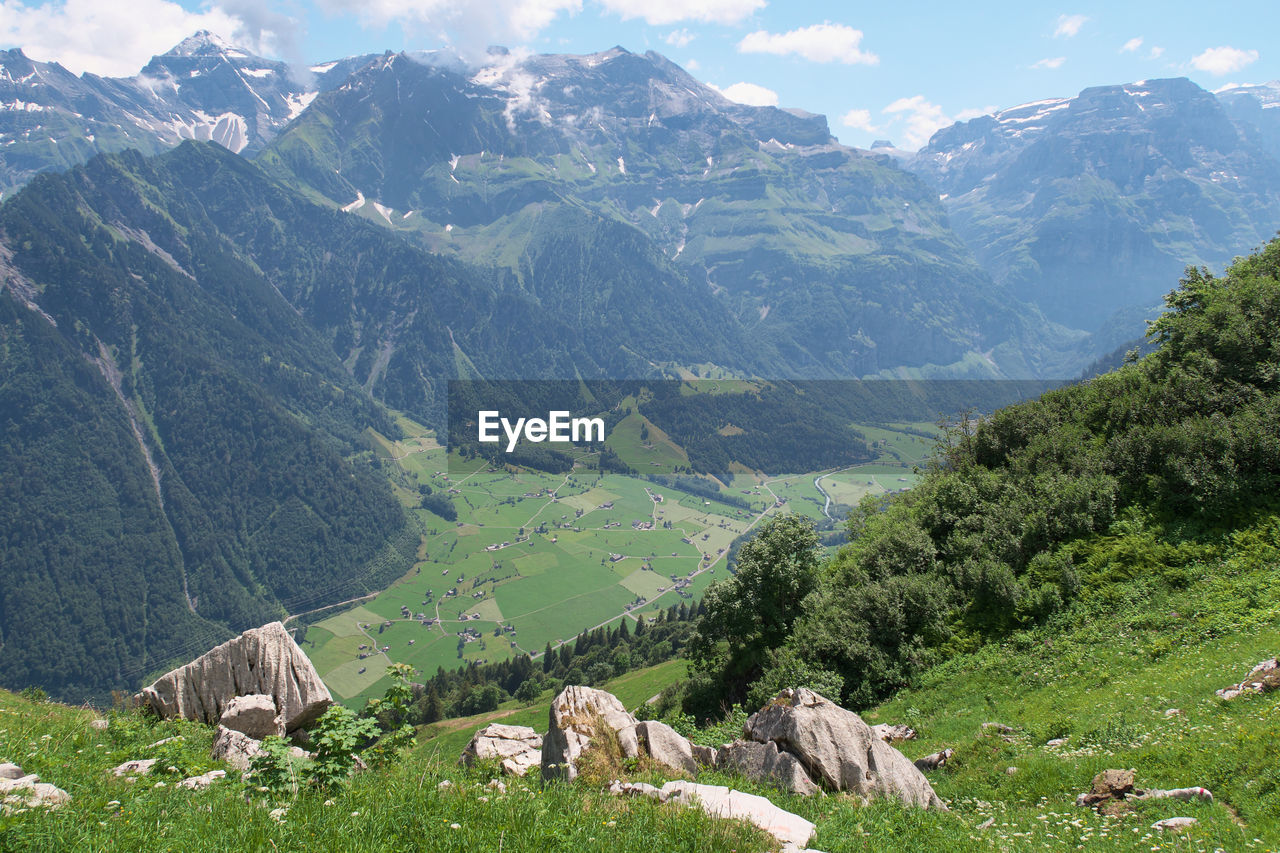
[0,32,370,193]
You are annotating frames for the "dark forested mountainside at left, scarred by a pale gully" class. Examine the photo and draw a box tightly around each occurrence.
[0,140,417,697]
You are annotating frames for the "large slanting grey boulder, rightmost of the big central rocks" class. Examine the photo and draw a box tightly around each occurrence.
[747,688,946,808]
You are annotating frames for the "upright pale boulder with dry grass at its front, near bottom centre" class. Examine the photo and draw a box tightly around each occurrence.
[541,685,640,781]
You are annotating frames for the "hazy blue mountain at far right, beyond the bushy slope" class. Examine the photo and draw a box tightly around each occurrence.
[908,78,1280,327]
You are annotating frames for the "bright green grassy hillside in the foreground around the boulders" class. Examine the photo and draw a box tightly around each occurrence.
[0,515,1280,853]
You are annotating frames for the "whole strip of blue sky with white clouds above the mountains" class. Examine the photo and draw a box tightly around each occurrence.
[0,0,1280,149]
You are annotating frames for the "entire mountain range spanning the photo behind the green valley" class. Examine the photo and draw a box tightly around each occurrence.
[0,33,1280,698]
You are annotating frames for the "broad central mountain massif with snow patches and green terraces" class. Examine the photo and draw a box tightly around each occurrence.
[259,47,1071,377]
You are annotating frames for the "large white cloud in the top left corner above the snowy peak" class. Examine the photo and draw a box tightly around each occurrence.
[0,0,248,77]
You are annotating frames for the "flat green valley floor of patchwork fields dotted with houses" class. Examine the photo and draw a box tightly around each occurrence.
[294,419,932,706]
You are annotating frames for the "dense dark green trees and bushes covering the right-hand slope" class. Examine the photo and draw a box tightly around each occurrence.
[685,240,1280,717]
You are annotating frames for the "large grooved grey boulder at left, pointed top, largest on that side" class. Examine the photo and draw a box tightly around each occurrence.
[138,622,333,731]
